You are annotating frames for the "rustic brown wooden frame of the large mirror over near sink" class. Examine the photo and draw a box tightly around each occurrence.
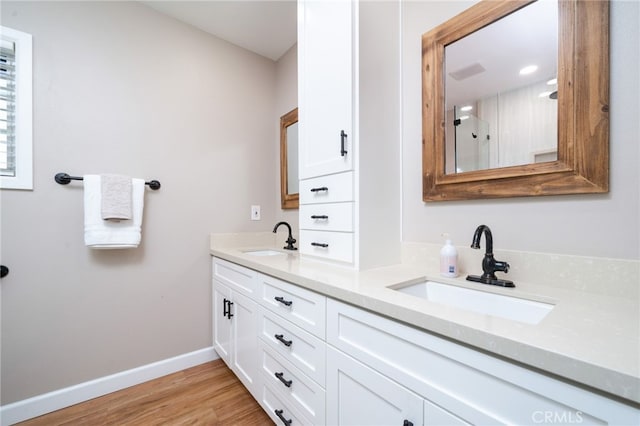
[422,0,609,201]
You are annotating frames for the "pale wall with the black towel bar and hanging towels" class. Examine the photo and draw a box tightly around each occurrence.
[0,1,279,405]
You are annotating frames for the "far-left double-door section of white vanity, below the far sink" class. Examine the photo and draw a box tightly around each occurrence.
[213,258,259,397]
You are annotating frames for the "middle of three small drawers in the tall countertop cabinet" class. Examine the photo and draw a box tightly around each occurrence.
[300,203,353,232]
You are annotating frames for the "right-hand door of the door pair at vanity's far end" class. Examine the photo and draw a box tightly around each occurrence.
[231,293,258,395]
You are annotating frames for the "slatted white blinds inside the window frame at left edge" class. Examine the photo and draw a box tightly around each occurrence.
[0,40,16,176]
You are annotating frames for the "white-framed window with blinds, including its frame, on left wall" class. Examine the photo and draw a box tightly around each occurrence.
[0,26,33,189]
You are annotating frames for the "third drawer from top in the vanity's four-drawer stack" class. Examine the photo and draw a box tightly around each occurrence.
[260,341,325,425]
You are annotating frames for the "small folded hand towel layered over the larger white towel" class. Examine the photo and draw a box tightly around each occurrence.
[100,175,133,220]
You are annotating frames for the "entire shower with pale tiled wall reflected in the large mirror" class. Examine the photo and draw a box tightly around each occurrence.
[446,78,558,173]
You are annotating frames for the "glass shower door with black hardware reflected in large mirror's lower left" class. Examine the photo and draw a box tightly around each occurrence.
[453,105,491,173]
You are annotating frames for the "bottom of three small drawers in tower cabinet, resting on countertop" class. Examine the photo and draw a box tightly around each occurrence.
[299,230,353,263]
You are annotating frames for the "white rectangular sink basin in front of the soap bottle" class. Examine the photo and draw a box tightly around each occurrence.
[394,281,554,324]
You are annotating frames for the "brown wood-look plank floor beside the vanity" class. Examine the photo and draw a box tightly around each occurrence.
[18,359,273,426]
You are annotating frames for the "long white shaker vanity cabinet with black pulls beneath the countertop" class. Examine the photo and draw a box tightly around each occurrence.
[213,258,640,426]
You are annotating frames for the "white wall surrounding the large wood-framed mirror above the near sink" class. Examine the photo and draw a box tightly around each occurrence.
[402,0,640,259]
